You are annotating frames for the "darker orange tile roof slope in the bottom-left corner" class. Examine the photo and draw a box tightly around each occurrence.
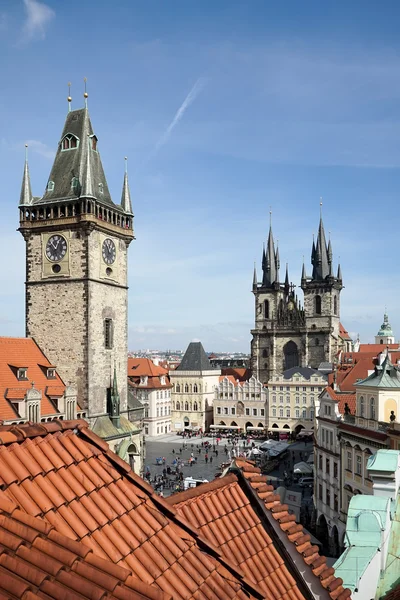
[0,491,172,600]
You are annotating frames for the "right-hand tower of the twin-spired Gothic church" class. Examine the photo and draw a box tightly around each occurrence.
[301,215,343,369]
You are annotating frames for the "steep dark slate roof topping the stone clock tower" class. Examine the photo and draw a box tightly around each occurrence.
[33,108,117,210]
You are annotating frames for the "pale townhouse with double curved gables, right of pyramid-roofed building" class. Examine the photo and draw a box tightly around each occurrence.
[213,375,268,433]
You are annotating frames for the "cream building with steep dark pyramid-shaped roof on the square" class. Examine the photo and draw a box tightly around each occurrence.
[169,342,221,431]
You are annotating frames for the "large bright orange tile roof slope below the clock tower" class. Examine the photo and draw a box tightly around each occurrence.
[0,420,263,600]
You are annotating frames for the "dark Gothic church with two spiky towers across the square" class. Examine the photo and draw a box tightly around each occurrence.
[251,217,343,383]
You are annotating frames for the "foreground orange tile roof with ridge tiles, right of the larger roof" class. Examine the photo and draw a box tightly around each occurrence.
[167,459,351,600]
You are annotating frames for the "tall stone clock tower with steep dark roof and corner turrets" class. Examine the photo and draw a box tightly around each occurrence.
[19,93,134,425]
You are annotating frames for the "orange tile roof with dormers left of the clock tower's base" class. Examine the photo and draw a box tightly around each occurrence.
[0,337,65,421]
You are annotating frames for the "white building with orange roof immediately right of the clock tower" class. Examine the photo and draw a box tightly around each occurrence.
[128,358,172,437]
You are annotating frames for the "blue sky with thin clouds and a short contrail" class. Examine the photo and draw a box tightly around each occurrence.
[0,0,400,351]
